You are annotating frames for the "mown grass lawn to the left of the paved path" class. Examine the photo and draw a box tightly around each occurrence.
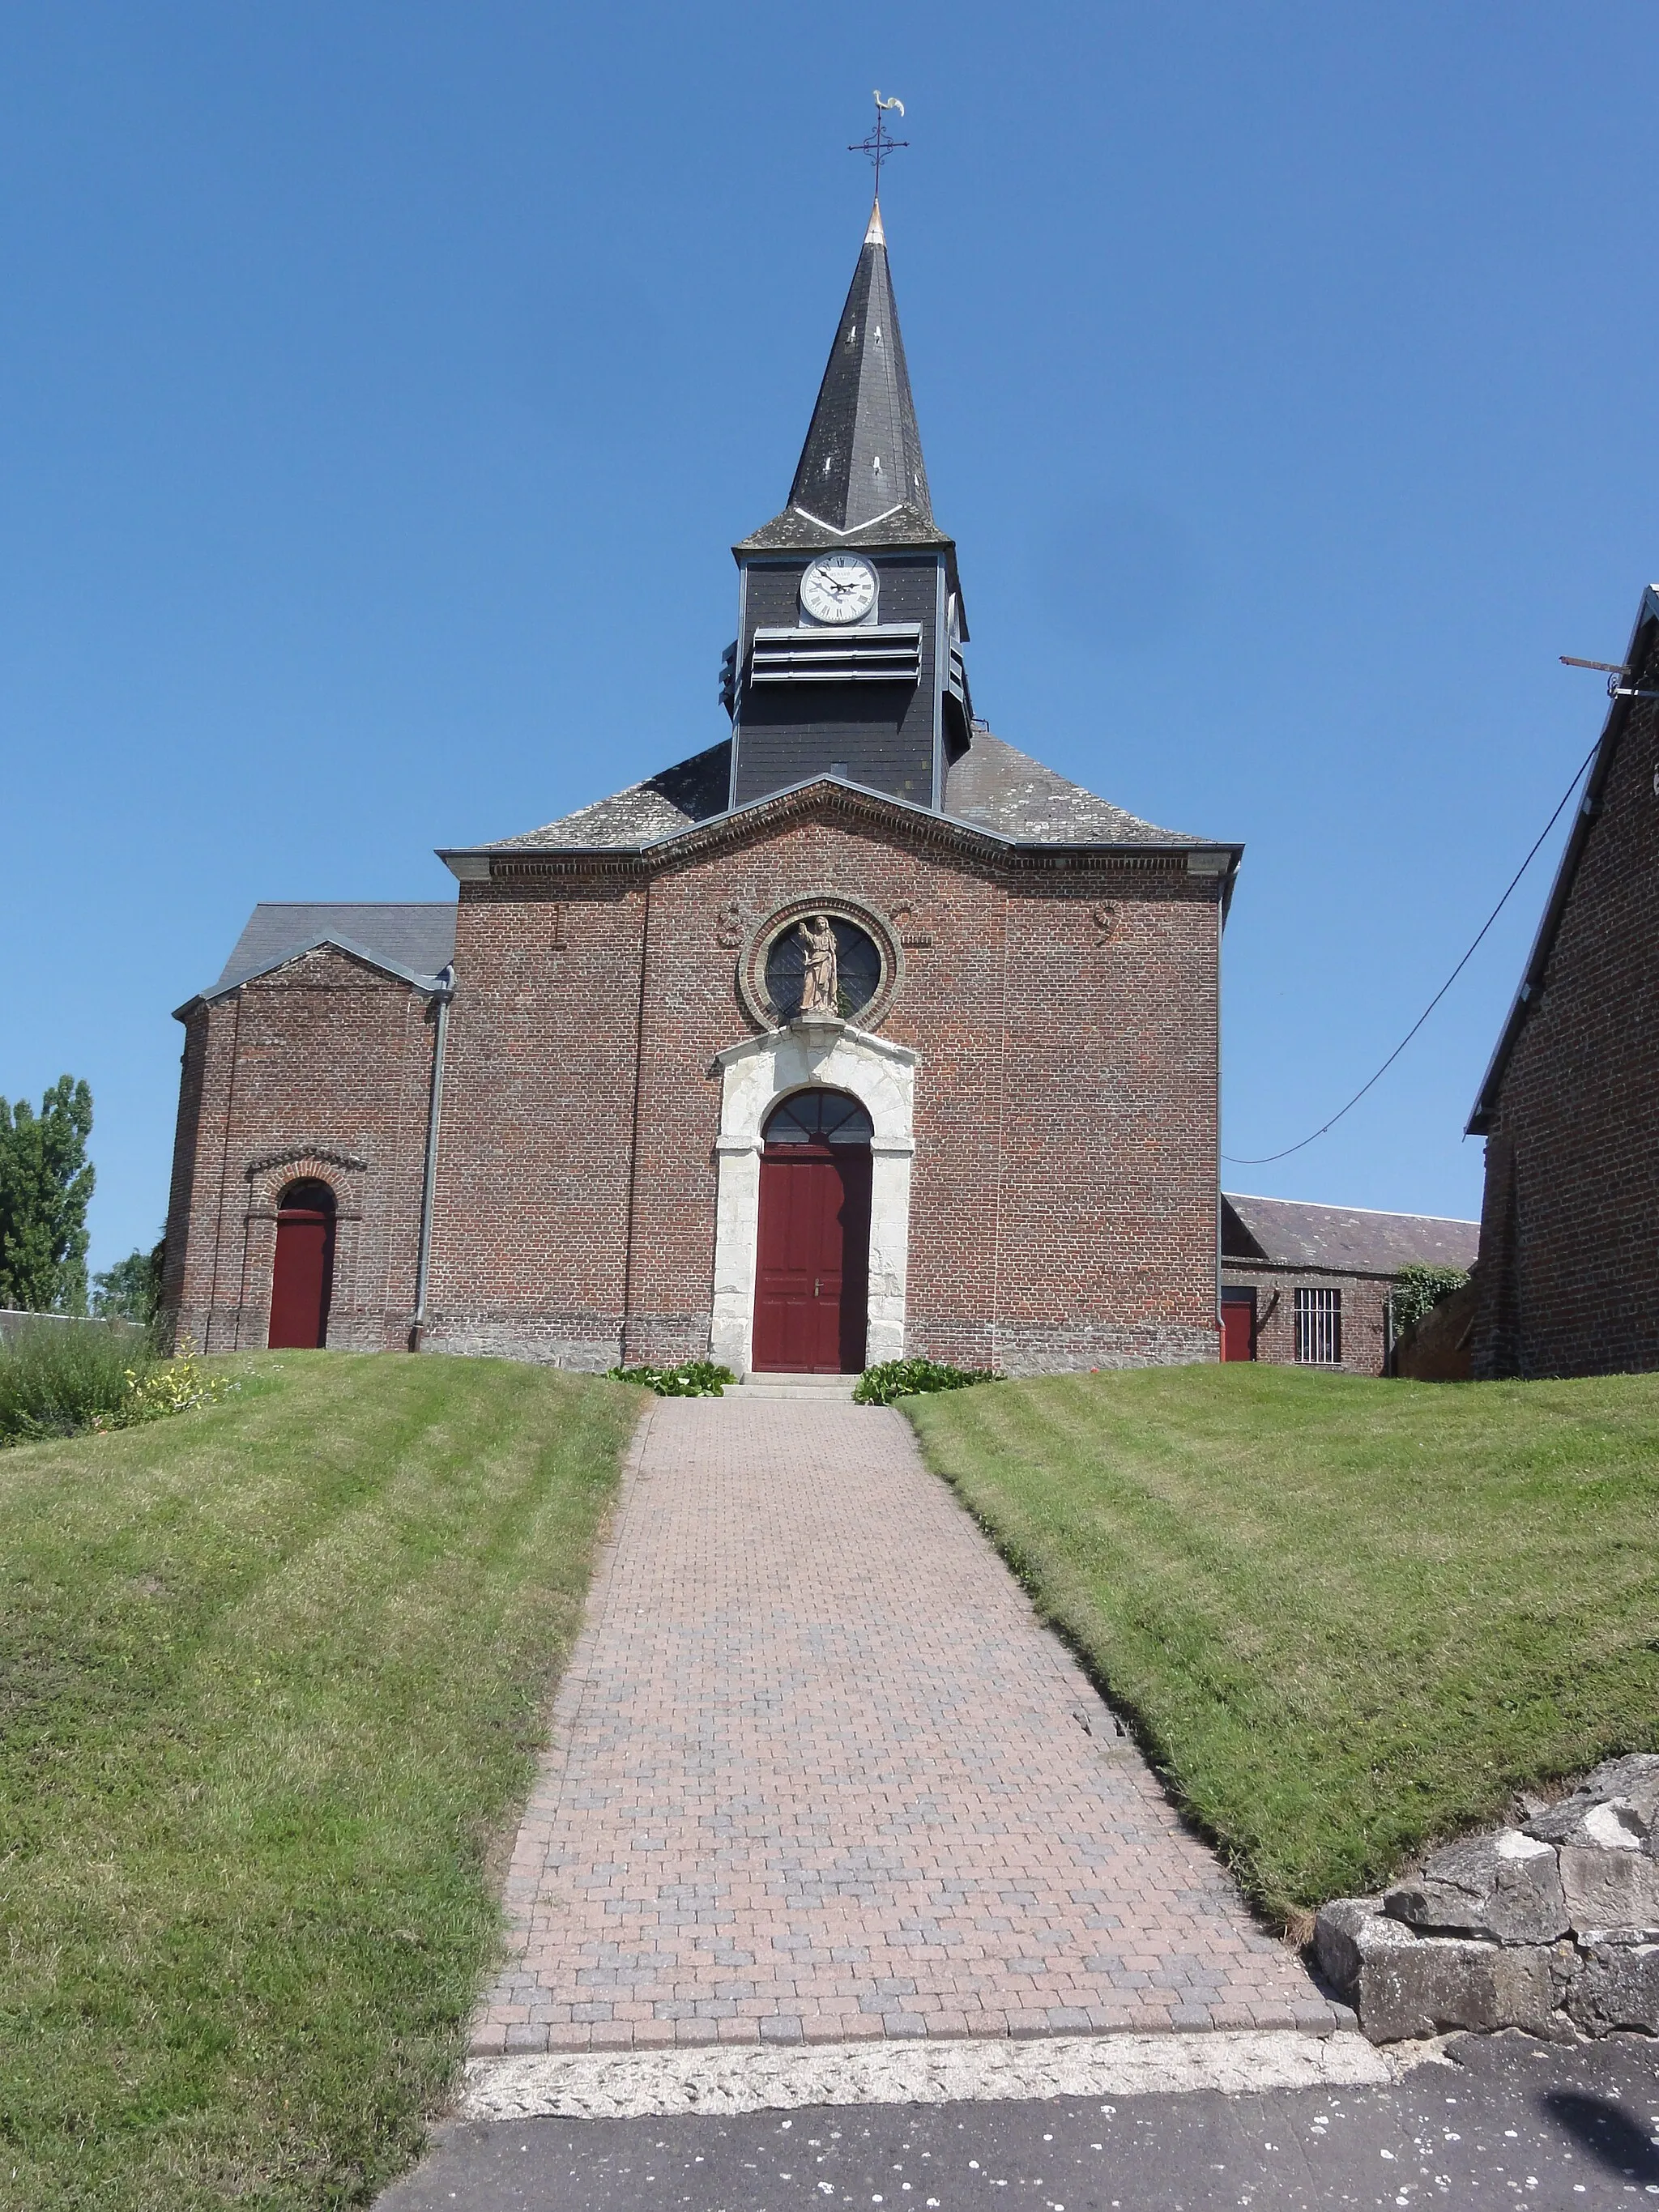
[0,1352,639,2212]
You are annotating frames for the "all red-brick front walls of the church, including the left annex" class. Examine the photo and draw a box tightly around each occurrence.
[168,801,1221,1371]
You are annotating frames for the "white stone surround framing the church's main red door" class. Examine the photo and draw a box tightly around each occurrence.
[710,1016,915,1376]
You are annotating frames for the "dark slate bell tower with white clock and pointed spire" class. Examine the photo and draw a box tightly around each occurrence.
[721,202,973,810]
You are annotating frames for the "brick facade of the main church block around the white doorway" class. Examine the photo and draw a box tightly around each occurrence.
[427,803,1219,1371]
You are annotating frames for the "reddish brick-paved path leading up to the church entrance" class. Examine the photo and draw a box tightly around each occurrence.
[473,1396,1334,2052]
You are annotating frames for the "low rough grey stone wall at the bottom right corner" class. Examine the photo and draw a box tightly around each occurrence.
[1314,1752,1659,2044]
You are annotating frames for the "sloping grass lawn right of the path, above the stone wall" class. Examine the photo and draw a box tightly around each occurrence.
[902,1362,1659,1924]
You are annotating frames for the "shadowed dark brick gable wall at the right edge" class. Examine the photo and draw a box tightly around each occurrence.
[1473,675,1659,1376]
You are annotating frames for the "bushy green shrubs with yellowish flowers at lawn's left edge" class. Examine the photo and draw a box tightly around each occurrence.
[0,1320,237,1444]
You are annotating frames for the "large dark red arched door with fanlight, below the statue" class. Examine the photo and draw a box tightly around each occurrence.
[754,1090,874,1376]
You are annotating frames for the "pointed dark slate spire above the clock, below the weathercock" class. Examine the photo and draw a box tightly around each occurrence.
[790,202,933,531]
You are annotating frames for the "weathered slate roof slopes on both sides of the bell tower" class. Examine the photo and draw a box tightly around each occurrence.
[473,730,1212,851]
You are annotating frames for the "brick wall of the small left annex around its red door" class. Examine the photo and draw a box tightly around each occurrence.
[164,949,442,1352]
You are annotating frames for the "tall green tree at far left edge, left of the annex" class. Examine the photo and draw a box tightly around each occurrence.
[0,1075,93,1314]
